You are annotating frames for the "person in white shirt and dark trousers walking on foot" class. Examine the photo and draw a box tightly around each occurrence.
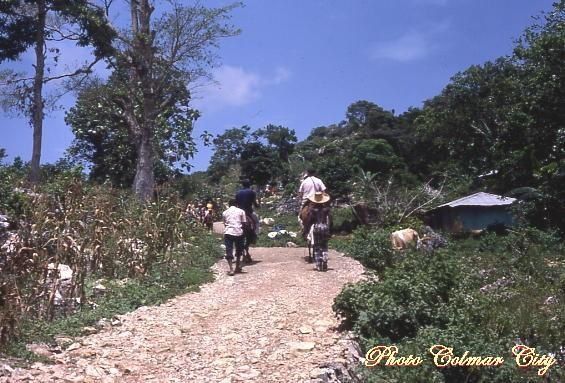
[222,199,247,275]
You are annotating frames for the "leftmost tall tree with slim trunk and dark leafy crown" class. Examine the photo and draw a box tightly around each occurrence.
[0,0,114,182]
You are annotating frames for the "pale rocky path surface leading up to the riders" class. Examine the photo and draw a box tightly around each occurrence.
[0,248,363,382]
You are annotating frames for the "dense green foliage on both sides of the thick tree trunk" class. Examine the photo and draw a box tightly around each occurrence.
[65,68,198,187]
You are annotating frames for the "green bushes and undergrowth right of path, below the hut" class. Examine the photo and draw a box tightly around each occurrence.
[334,228,565,382]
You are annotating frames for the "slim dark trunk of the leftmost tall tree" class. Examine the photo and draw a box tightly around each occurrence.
[29,0,47,184]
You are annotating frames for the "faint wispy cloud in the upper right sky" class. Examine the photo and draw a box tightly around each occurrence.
[369,22,449,62]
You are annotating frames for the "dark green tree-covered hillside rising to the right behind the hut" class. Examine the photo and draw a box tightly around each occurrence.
[268,1,565,233]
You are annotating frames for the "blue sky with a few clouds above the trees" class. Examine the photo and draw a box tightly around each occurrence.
[0,0,552,170]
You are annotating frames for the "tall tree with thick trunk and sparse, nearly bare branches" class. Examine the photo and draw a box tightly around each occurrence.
[110,0,239,200]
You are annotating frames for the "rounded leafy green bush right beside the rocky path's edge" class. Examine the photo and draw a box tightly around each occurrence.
[335,252,463,342]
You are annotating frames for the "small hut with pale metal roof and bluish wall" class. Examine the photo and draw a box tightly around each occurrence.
[426,192,516,232]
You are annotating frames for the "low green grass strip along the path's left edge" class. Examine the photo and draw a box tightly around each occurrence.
[4,236,222,361]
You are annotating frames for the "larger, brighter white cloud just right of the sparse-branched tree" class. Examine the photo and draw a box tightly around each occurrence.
[195,65,291,110]
